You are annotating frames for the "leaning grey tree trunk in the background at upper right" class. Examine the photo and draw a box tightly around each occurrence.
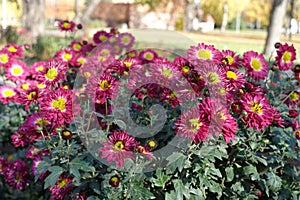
[264,0,288,56]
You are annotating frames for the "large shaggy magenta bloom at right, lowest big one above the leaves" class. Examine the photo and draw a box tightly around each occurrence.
[240,93,273,131]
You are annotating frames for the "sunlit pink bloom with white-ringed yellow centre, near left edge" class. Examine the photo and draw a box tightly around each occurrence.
[5,60,28,82]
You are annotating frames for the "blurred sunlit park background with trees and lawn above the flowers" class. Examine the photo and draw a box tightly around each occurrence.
[0,0,300,56]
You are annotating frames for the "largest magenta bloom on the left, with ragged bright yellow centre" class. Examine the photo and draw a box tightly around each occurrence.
[39,89,73,125]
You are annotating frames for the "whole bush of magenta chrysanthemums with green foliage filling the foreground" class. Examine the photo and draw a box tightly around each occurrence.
[0,20,300,200]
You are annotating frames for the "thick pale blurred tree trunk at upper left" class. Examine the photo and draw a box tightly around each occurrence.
[22,0,45,42]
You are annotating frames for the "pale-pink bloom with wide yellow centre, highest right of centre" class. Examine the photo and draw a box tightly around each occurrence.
[187,43,222,66]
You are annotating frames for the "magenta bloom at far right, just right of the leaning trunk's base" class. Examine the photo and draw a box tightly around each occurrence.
[275,43,296,70]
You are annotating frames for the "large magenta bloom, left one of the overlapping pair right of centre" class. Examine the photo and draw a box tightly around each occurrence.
[175,108,209,144]
